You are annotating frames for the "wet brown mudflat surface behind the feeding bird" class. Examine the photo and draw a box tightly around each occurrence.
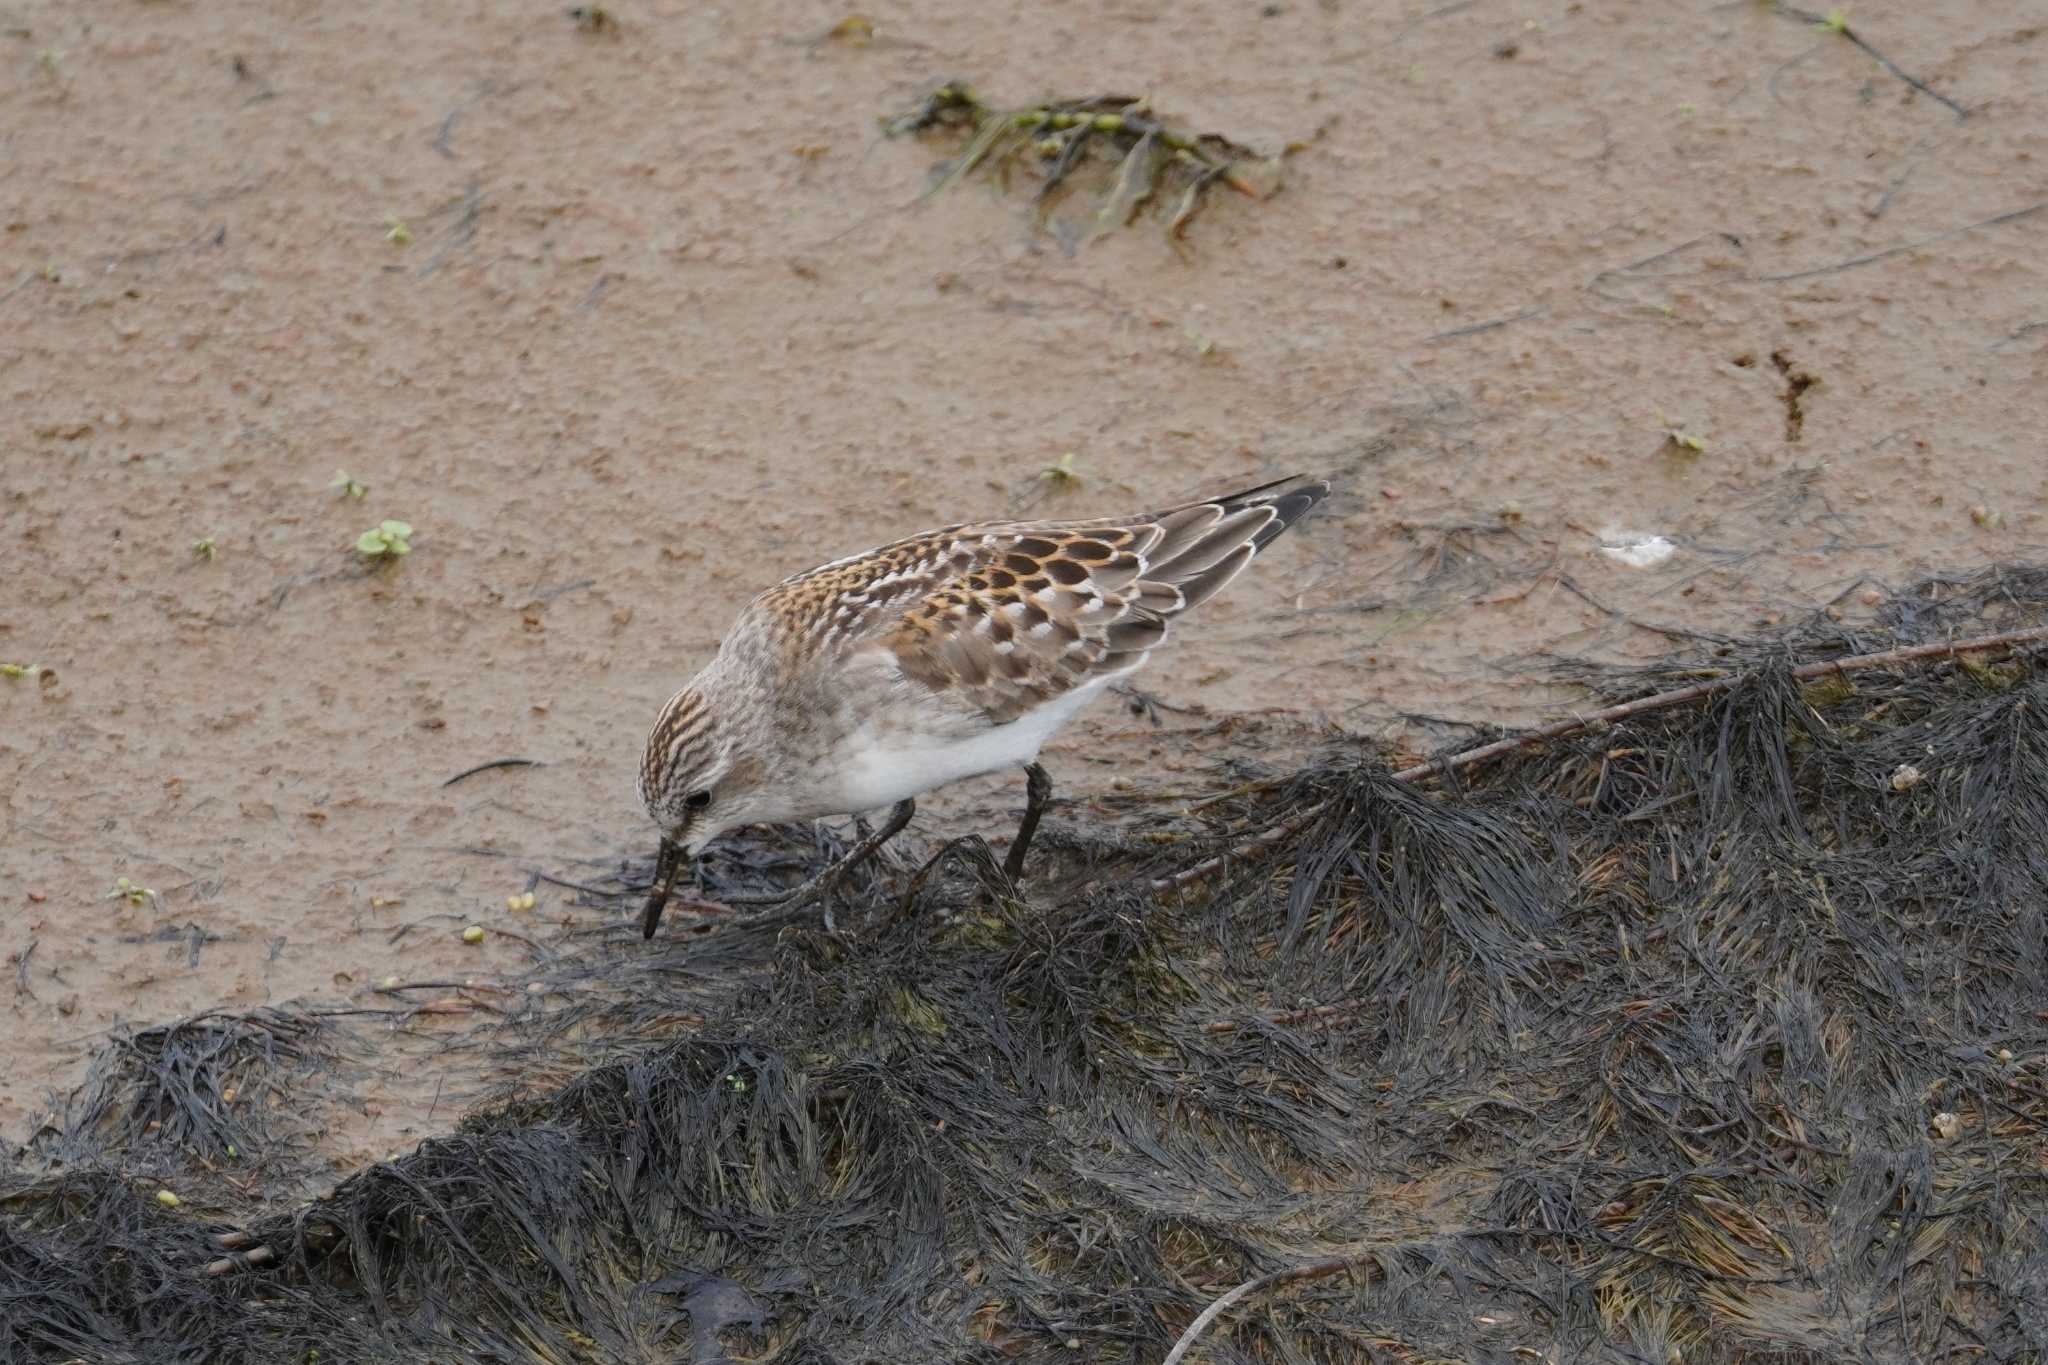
[0,0,2048,1169]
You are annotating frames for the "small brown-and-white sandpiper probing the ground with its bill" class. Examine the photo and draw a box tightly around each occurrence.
[639,475,1329,937]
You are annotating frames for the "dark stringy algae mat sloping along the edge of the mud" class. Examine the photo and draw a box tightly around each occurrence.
[0,569,2048,1365]
